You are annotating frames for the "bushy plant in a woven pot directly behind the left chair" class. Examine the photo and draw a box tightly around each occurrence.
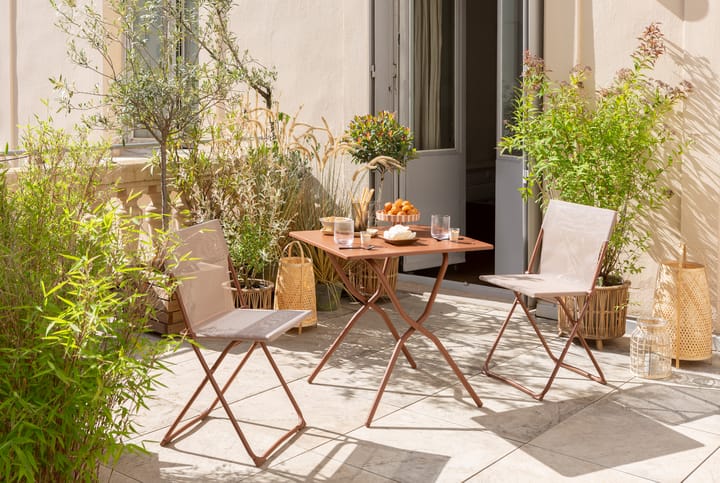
[176,99,309,308]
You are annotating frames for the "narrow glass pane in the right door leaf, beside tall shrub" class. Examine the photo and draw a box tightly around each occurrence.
[500,0,523,144]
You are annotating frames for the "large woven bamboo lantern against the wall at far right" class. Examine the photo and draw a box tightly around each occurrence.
[653,247,712,367]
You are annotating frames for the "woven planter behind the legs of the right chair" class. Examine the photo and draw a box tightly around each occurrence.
[558,282,630,349]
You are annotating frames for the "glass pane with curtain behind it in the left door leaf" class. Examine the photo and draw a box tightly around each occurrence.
[412,0,455,150]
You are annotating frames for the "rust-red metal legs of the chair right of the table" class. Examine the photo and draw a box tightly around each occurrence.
[483,293,607,401]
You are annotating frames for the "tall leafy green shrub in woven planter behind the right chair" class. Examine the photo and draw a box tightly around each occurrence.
[499,23,691,346]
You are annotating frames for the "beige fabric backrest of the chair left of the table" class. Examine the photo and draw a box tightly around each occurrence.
[171,220,235,330]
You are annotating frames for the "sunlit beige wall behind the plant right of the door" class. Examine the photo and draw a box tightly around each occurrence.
[544,0,720,332]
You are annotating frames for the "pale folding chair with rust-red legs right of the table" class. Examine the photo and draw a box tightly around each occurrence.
[480,200,616,400]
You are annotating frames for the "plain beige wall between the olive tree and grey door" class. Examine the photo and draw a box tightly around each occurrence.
[231,0,370,130]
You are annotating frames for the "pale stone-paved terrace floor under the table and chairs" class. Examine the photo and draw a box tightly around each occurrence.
[101,284,720,483]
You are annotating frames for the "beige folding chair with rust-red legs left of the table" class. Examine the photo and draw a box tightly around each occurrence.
[160,220,309,466]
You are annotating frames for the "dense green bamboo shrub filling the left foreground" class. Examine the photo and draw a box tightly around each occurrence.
[0,122,174,481]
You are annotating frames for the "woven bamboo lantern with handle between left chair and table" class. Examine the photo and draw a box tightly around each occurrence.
[274,240,317,332]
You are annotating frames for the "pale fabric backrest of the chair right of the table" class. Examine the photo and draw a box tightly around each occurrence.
[539,200,617,288]
